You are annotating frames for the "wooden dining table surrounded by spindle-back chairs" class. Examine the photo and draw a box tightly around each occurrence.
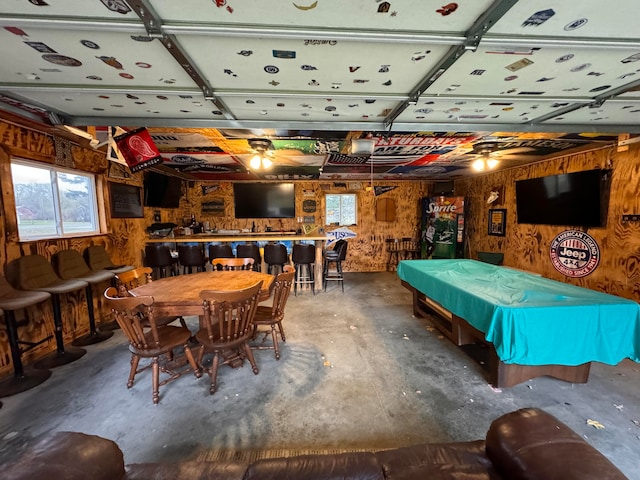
[130,270,275,316]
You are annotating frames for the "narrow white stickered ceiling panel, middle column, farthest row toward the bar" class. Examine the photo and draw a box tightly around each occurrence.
[220,95,398,122]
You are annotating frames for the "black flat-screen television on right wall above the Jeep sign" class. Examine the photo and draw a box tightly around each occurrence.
[516,170,609,227]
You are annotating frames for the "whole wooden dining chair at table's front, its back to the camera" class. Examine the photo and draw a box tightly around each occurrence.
[196,280,262,395]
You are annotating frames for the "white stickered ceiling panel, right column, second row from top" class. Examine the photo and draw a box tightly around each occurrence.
[425,47,640,99]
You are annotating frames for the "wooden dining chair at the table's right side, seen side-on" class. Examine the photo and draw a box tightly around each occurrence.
[251,265,295,360]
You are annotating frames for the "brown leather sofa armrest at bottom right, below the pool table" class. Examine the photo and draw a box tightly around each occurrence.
[486,408,628,480]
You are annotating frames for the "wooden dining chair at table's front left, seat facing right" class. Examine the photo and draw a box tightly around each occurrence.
[104,287,202,403]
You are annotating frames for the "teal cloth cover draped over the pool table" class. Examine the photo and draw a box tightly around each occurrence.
[397,259,640,366]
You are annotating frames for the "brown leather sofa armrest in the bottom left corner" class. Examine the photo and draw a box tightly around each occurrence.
[1,432,125,480]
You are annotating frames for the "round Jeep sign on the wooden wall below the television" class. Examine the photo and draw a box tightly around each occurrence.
[549,230,600,278]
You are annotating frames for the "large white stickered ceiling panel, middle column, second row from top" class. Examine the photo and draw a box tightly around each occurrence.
[178,35,448,95]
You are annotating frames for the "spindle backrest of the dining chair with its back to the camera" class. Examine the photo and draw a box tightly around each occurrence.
[200,280,262,345]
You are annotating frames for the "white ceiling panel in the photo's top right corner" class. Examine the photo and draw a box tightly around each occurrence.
[490,0,638,39]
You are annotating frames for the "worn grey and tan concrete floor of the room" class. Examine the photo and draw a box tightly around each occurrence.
[0,272,640,479]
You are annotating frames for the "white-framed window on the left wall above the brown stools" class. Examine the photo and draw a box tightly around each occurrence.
[11,160,100,241]
